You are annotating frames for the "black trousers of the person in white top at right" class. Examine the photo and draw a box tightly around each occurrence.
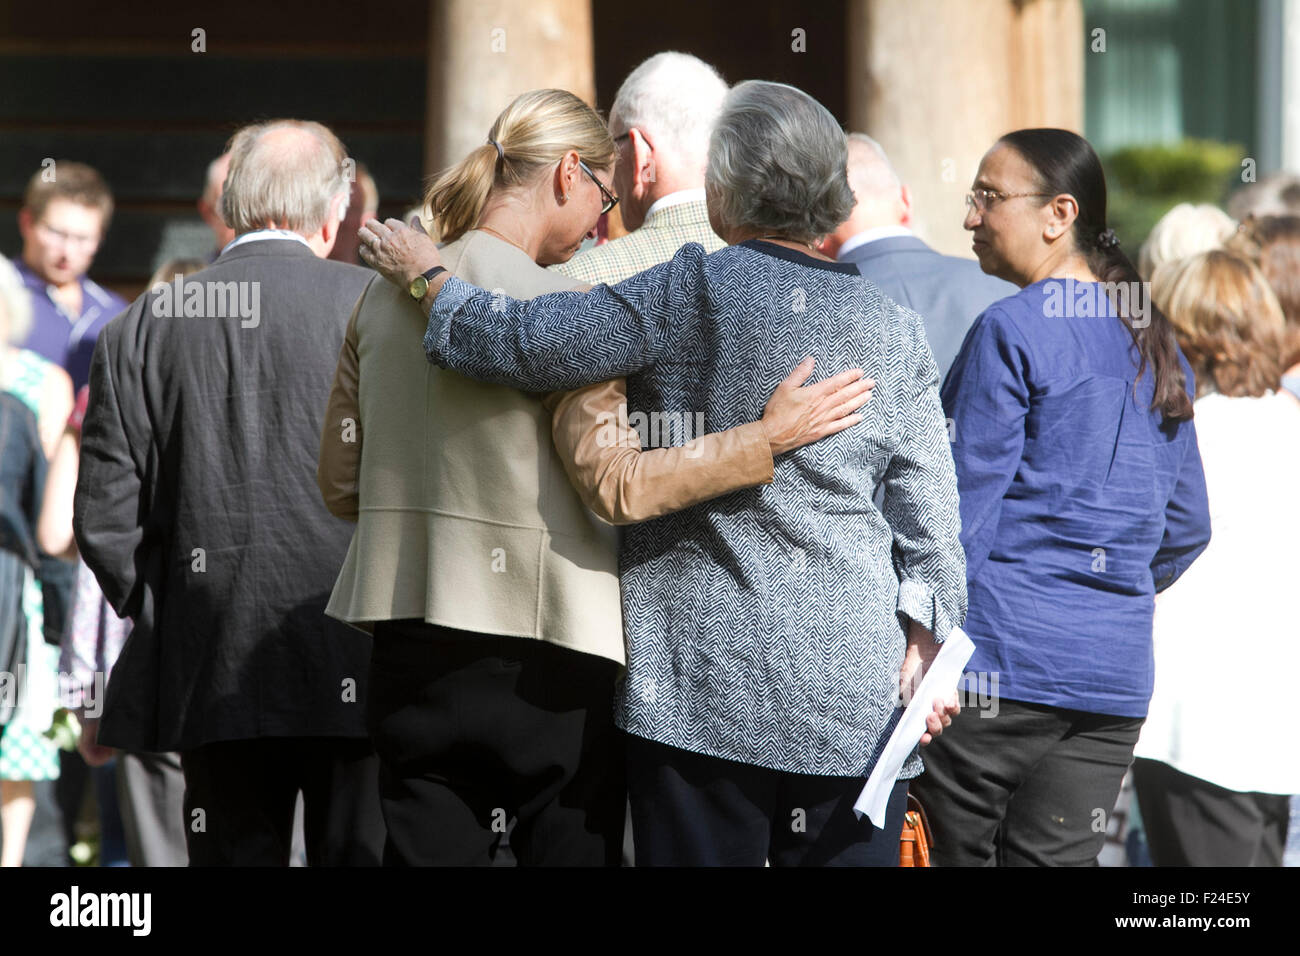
[1134,757,1291,866]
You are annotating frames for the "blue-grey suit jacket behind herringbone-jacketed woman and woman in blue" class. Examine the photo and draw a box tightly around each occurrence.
[844,235,1019,381]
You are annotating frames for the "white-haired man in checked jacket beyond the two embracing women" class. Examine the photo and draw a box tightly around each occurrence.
[551,53,727,285]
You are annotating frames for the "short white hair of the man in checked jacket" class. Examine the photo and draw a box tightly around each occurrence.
[610,51,727,169]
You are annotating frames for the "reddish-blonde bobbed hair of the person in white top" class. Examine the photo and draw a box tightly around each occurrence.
[1152,250,1286,397]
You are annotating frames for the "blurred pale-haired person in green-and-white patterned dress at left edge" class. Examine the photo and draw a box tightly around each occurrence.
[0,258,73,866]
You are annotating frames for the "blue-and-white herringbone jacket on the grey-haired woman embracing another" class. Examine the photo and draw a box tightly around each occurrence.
[425,241,966,778]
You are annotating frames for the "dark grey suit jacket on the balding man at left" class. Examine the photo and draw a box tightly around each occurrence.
[73,239,374,750]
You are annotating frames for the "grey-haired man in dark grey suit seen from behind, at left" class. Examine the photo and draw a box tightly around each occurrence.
[74,120,384,865]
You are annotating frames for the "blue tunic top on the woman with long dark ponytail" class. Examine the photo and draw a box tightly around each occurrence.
[943,280,1210,717]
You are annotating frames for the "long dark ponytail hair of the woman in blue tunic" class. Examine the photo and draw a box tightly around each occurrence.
[997,129,1192,421]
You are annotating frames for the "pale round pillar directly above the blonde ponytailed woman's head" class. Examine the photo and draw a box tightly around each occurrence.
[424,0,595,176]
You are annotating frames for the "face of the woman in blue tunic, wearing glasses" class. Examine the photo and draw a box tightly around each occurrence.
[962,144,1069,286]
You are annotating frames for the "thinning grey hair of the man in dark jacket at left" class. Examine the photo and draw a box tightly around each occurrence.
[221,120,352,235]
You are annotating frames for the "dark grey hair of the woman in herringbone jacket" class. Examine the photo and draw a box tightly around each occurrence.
[705,79,853,242]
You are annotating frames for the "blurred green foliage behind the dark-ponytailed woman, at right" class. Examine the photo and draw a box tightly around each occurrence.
[1104,139,1245,252]
